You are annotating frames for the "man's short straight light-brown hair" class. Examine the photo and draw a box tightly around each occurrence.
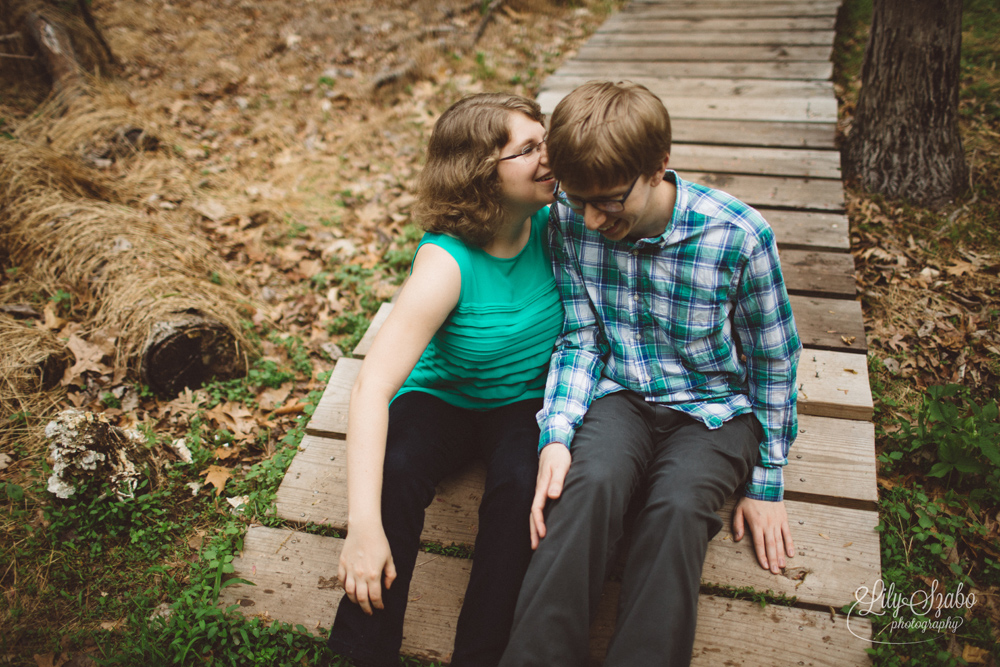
[546,81,671,190]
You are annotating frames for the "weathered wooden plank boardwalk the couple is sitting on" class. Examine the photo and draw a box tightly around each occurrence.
[223,0,880,667]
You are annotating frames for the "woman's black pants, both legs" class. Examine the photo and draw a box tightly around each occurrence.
[329,392,542,667]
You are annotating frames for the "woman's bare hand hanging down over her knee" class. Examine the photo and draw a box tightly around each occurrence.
[337,525,396,616]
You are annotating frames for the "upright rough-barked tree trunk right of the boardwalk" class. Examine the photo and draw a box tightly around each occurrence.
[843,0,969,206]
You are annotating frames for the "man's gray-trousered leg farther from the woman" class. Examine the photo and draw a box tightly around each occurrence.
[605,407,762,667]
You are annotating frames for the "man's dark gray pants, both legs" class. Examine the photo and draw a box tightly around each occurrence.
[500,391,763,667]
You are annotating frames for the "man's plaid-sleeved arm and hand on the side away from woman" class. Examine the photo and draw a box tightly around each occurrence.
[733,228,802,573]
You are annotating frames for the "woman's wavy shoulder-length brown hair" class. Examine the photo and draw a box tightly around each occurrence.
[416,93,543,247]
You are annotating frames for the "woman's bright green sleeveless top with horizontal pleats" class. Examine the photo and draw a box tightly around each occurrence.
[396,207,563,410]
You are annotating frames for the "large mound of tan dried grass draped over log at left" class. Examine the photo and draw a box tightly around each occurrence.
[0,90,253,386]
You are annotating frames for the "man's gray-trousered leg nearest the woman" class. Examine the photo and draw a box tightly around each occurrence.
[500,391,652,667]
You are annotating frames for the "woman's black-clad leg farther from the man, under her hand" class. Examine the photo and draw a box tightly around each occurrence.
[328,392,474,666]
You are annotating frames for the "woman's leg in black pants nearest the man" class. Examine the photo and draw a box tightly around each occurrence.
[451,398,542,667]
